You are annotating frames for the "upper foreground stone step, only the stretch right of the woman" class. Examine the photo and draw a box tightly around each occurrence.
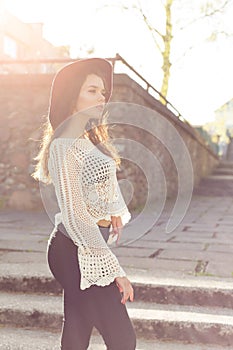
[132,276,233,309]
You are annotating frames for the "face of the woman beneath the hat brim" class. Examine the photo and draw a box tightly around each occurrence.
[76,74,106,114]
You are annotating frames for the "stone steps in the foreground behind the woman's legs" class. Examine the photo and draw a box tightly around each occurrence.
[0,268,233,350]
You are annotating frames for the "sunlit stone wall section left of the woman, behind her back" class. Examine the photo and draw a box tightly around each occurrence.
[0,75,52,209]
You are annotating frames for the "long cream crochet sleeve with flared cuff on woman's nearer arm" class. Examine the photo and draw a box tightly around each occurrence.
[49,142,125,289]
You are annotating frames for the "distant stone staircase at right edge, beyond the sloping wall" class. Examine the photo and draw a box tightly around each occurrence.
[194,161,233,196]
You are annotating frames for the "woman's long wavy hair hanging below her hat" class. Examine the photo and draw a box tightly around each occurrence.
[32,113,121,183]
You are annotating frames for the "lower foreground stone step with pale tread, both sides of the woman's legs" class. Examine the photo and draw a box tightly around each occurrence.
[0,293,233,346]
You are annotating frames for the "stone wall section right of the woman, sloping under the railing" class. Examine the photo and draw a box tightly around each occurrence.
[112,74,219,207]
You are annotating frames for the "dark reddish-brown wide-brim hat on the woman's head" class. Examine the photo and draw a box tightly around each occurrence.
[48,58,113,129]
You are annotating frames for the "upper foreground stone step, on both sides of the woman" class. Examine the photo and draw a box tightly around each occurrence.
[0,276,233,309]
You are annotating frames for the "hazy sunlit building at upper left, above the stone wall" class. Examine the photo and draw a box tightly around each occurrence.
[0,0,69,74]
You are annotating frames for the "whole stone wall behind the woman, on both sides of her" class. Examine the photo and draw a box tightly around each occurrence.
[0,74,218,209]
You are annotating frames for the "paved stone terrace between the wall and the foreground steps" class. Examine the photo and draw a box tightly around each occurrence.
[0,196,233,285]
